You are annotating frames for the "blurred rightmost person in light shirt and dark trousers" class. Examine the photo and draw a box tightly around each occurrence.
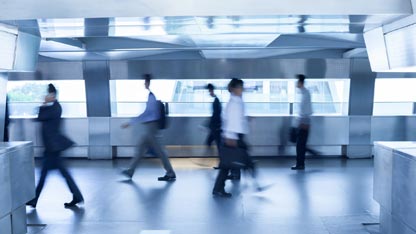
[291,74,312,170]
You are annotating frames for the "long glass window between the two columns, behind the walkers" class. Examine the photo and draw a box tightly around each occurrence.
[110,79,350,117]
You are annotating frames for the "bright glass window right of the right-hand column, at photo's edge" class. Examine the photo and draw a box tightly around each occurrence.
[373,78,416,115]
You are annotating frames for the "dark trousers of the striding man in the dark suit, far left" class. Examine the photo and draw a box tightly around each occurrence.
[35,151,84,201]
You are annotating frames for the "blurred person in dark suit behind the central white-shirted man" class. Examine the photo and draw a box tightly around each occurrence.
[206,84,222,152]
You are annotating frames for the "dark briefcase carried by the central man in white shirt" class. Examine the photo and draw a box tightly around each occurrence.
[219,144,249,169]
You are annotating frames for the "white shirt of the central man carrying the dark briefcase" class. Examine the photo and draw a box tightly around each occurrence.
[222,95,248,140]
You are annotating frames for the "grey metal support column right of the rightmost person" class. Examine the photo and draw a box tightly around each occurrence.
[346,59,377,158]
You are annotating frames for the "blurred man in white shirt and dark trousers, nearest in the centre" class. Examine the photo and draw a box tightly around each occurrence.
[213,78,255,197]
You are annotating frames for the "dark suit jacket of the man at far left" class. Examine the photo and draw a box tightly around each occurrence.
[37,101,74,152]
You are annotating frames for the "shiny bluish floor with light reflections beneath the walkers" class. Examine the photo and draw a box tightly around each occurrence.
[27,158,378,234]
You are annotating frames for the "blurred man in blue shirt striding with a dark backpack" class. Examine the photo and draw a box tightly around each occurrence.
[121,74,176,181]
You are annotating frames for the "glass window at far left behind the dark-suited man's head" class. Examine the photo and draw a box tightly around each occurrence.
[7,80,87,118]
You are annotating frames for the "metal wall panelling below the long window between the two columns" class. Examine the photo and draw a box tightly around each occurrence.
[110,116,349,157]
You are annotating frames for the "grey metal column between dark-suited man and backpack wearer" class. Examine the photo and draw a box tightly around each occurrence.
[83,61,112,159]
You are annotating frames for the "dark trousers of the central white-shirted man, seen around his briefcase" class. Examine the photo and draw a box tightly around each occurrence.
[214,134,255,192]
